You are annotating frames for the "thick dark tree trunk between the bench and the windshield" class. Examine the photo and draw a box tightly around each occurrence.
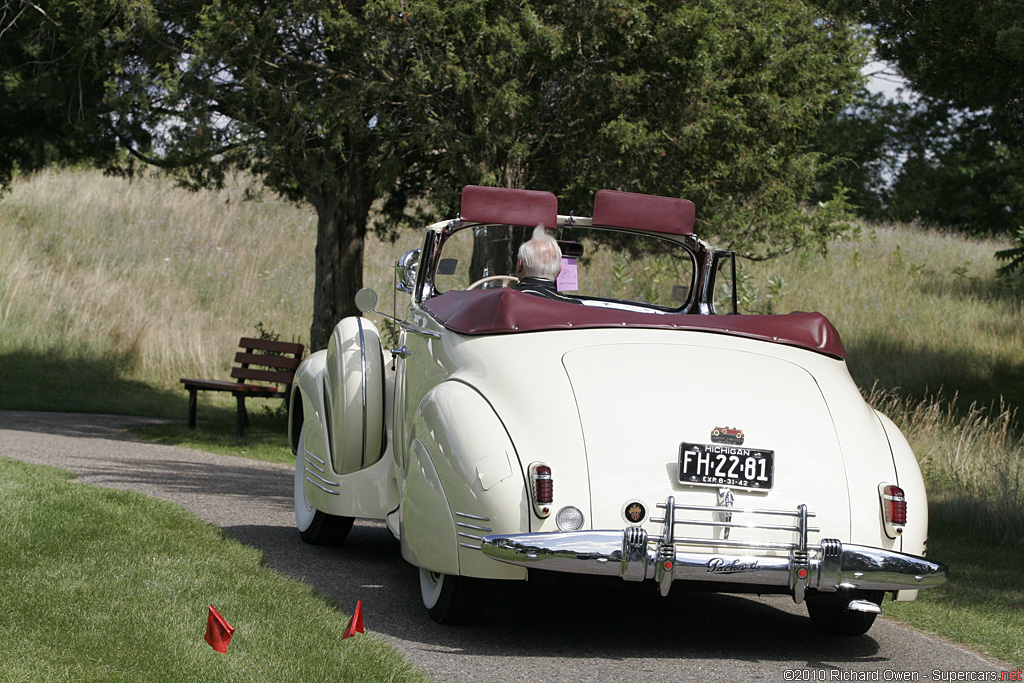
[306,161,373,351]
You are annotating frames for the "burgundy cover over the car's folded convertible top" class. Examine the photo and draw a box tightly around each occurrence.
[423,288,846,358]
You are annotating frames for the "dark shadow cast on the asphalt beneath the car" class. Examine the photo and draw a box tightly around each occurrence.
[225,521,885,667]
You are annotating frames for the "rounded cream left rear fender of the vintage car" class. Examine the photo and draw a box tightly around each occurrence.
[401,381,530,580]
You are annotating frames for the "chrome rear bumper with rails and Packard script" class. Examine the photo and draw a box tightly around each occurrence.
[480,497,946,603]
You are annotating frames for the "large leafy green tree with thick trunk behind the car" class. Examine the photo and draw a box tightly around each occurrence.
[4,0,863,348]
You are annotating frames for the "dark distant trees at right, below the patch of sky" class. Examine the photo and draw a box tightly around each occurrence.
[818,93,1024,233]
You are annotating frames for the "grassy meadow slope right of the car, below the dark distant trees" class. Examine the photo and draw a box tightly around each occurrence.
[741,226,1024,405]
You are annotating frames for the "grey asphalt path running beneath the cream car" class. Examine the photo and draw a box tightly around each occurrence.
[0,412,1020,683]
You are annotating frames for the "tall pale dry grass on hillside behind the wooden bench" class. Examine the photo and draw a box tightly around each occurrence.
[0,170,419,386]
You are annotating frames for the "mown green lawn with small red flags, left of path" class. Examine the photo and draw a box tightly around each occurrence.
[0,459,427,683]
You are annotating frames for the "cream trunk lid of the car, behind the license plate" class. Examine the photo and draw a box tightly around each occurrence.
[563,344,850,543]
